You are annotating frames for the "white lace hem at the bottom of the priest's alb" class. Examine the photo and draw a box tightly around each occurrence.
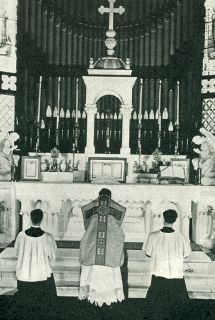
[78,286,125,307]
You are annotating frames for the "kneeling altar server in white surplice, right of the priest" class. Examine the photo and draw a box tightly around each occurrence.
[146,209,191,319]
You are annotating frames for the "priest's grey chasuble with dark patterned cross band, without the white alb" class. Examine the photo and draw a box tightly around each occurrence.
[80,197,126,267]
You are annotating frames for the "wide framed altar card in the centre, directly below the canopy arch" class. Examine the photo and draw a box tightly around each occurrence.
[88,157,127,182]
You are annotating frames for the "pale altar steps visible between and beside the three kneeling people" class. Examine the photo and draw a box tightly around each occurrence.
[0,247,215,299]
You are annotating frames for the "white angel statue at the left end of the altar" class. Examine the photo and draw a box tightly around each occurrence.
[0,131,19,181]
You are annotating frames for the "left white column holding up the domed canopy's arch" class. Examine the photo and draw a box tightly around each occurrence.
[85,104,97,155]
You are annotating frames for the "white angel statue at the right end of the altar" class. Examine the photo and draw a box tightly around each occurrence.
[192,128,215,186]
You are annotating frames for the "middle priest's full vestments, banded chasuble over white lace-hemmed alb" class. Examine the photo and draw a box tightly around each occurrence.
[79,197,126,306]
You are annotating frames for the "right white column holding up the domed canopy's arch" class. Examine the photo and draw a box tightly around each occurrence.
[120,104,132,156]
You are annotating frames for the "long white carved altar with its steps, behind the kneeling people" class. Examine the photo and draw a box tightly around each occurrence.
[0,182,215,299]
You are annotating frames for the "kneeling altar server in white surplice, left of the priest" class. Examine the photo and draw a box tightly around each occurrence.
[15,209,57,305]
